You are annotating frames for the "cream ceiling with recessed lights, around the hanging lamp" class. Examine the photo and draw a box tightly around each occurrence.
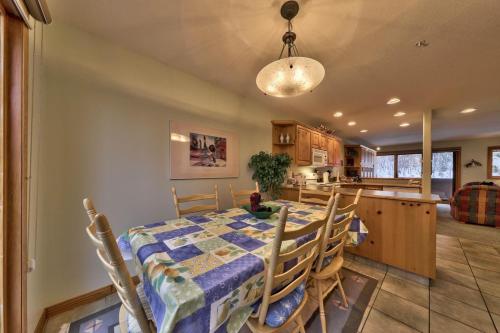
[49,0,500,145]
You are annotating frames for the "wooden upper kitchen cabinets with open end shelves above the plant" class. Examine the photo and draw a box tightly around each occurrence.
[271,120,342,166]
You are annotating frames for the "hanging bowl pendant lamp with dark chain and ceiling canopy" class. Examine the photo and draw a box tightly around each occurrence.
[256,1,325,97]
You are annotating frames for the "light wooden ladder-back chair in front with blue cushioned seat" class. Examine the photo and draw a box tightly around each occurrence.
[247,202,326,333]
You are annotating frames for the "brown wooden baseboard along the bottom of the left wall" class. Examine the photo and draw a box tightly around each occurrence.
[35,276,140,333]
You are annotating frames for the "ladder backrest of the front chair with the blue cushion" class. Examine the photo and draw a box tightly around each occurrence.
[259,206,332,325]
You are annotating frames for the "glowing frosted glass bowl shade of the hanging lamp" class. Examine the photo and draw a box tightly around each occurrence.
[256,57,325,97]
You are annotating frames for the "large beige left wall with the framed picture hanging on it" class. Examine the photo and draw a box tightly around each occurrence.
[28,23,316,331]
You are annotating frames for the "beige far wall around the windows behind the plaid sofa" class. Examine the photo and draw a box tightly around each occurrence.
[381,137,500,185]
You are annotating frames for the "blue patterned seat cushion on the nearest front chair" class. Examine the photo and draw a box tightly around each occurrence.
[251,283,305,328]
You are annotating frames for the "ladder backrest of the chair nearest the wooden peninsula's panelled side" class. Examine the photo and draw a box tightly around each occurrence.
[316,189,363,273]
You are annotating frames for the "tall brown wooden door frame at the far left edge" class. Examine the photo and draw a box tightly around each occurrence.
[1,8,29,333]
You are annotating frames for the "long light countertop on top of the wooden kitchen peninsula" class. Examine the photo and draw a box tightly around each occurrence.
[283,183,441,203]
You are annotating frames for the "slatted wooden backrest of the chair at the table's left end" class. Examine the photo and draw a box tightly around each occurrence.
[83,199,152,333]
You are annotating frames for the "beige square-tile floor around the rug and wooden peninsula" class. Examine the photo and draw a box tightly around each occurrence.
[45,205,500,333]
